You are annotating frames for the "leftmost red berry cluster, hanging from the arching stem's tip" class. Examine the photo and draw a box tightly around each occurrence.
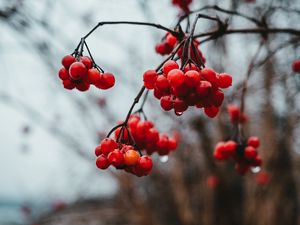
[58,55,115,91]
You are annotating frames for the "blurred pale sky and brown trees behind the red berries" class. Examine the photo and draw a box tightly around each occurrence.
[0,0,300,225]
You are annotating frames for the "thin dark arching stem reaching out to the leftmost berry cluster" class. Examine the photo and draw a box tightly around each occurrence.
[83,21,179,39]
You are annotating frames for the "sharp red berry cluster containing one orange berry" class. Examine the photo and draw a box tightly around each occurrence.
[95,138,153,177]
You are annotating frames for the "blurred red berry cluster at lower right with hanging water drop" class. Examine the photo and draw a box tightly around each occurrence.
[214,137,262,175]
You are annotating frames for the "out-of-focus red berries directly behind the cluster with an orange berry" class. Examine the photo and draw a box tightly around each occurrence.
[115,114,177,155]
